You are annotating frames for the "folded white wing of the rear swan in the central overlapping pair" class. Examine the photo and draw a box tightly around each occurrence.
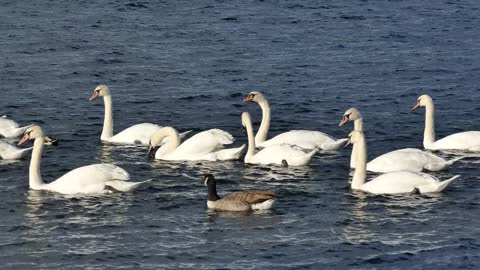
[257,130,336,149]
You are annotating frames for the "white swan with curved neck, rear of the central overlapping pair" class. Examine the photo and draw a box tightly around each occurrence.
[243,91,347,150]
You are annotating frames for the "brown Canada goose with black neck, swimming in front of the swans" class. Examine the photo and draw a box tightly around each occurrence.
[203,174,276,211]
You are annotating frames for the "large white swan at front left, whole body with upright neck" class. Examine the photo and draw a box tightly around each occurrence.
[18,125,148,194]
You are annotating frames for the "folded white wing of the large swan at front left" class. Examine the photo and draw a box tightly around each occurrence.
[47,164,130,194]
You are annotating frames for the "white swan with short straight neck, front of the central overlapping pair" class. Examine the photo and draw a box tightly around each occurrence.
[242,112,319,166]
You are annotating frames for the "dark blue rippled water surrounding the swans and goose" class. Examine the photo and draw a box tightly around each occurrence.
[0,0,480,269]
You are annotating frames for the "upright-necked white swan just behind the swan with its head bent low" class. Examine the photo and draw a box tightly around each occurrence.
[90,85,190,145]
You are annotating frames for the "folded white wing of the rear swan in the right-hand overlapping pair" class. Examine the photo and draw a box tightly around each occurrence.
[367,148,446,172]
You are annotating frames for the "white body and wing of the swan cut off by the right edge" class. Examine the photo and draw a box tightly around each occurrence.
[433,131,480,150]
